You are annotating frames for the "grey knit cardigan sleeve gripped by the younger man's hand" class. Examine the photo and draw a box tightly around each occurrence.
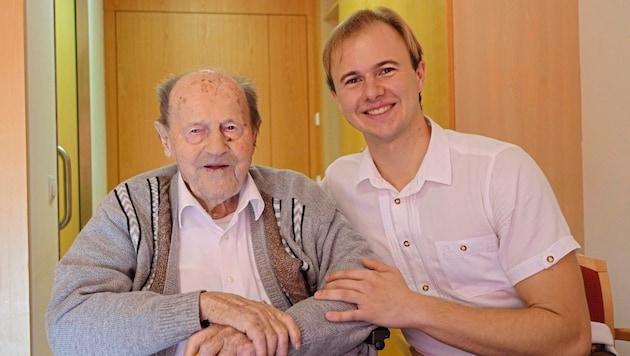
[252,165,378,355]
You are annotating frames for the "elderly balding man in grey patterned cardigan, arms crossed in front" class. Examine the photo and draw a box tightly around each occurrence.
[46,70,374,355]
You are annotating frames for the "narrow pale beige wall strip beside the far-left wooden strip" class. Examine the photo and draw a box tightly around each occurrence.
[25,1,59,356]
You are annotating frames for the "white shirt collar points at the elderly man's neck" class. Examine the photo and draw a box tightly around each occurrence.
[177,172,265,228]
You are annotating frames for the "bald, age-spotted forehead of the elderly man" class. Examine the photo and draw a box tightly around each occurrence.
[169,72,246,110]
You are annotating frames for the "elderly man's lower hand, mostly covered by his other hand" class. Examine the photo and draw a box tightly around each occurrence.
[184,324,256,356]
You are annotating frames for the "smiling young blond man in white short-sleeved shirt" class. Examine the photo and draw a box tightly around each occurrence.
[315,8,590,355]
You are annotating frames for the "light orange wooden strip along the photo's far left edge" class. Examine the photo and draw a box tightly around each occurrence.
[0,1,29,355]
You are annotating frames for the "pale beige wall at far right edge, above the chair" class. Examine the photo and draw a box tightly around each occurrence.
[579,0,630,355]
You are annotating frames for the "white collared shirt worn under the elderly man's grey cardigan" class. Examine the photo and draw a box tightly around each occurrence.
[176,173,270,355]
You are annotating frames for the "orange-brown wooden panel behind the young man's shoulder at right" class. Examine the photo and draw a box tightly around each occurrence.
[452,0,584,244]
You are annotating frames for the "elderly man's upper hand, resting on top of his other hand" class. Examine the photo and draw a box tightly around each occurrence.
[199,292,302,356]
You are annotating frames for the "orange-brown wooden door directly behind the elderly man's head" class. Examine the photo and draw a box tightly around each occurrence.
[105,0,322,188]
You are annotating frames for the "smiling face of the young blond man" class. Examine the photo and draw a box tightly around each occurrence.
[330,22,424,144]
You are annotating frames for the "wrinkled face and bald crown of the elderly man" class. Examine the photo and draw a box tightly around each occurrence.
[156,72,256,211]
